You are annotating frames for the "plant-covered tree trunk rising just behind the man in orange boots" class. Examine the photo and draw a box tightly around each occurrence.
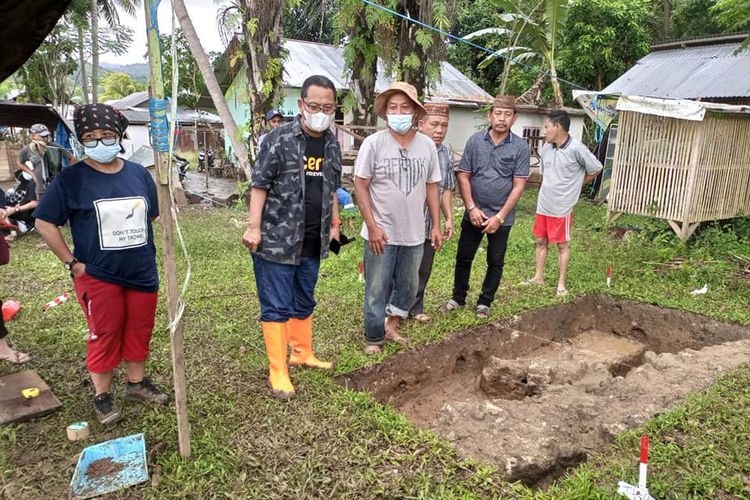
[241,0,287,165]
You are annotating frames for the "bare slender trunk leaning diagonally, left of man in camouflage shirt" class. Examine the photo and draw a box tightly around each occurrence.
[172,0,250,179]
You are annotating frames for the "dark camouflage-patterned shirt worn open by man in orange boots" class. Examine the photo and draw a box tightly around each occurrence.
[251,115,341,265]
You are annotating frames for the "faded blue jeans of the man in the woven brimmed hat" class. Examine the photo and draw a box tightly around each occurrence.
[365,243,423,344]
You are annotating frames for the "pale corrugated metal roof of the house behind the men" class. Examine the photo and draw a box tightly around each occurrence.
[284,40,492,105]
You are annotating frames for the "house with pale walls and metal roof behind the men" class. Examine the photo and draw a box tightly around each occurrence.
[216,37,583,164]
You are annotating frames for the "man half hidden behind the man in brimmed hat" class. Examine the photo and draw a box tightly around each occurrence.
[409,102,456,322]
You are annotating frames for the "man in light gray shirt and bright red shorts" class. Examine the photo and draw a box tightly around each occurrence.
[524,110,602,296]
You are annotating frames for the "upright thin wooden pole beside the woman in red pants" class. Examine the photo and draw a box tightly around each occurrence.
[144,0,191,457]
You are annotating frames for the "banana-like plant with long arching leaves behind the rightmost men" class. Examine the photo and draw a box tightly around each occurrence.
[464,0,568,106]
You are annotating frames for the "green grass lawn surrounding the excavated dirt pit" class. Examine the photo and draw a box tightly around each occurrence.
[0,191,750,500]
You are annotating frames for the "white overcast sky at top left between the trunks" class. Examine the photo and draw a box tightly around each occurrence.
[101,0,224,64]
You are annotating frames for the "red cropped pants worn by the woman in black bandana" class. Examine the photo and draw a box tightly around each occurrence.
[73,274,157,373]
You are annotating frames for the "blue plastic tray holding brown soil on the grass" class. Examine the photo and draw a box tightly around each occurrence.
[70,433,148,500]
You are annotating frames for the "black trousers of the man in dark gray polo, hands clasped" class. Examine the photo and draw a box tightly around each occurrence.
[453,215,511,307]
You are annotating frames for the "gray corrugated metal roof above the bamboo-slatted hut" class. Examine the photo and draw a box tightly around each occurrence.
[602,43,750,99]
